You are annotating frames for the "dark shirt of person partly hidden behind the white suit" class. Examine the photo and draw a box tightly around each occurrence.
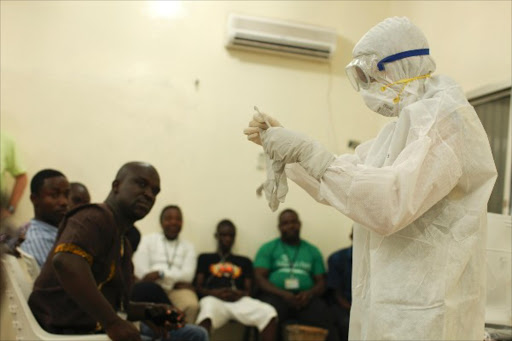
[327,246,352,302]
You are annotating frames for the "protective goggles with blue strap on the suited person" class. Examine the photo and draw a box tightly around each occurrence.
[345,49,429,91]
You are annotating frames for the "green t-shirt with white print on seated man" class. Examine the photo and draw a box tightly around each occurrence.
[254,238,325,291]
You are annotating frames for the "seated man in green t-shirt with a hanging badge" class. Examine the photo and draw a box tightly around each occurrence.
[254,209,338,341]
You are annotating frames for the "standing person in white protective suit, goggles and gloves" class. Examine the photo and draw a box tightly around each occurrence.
[244,18,496,340]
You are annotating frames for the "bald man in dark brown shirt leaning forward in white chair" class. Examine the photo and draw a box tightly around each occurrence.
[28,162,208,341]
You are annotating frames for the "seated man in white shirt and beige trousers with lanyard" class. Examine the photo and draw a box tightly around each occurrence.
[133,205,199,323]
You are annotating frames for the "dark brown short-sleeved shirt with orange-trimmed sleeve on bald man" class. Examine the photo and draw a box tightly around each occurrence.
[28,204,133,334]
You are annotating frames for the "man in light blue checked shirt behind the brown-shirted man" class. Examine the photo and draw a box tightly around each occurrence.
[20,169,69,267]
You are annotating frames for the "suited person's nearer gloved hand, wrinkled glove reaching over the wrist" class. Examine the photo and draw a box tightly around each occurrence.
[261,127,334,180]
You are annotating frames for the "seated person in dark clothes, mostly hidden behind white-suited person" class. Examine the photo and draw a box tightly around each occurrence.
[326,228,352,341]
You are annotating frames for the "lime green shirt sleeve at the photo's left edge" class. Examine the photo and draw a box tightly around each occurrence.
[0,131,26,193]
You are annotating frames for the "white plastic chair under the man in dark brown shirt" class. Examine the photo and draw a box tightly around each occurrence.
[2,255,110,341]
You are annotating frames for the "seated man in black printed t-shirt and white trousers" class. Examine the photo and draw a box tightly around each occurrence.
[196,220,277,341]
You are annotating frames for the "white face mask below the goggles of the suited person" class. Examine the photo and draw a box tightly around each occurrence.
[360,82,398,117]
